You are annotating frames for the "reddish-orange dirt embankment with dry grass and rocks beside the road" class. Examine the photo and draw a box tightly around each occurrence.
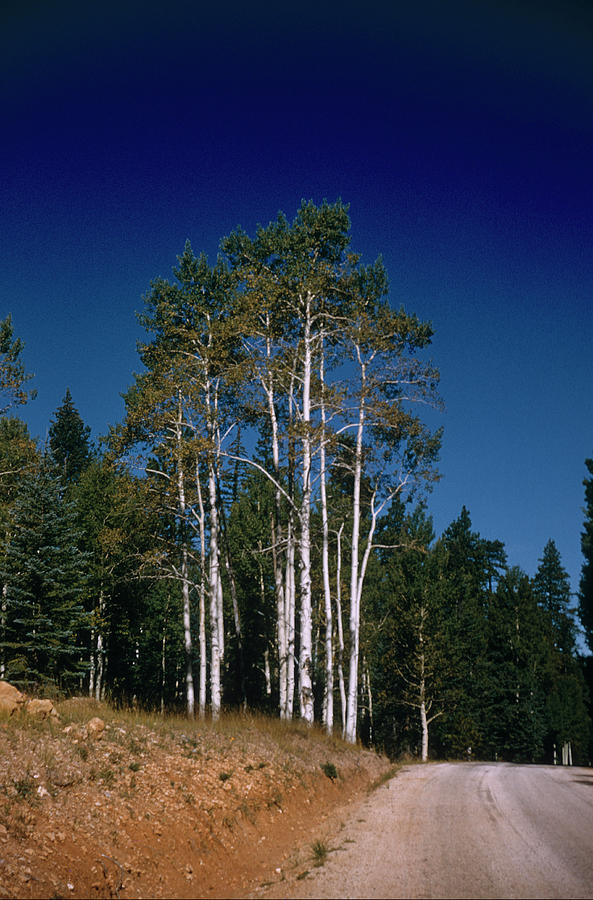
[0,700,389,900]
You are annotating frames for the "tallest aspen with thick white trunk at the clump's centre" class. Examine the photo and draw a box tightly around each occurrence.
[222,202,350,723]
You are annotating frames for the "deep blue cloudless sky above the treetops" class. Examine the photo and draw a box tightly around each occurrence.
[0,0,593,620]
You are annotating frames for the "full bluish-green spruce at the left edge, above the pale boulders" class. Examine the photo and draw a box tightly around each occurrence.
[1,458,87,689]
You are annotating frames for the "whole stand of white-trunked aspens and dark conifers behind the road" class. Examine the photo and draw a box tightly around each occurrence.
[0,202,593,764]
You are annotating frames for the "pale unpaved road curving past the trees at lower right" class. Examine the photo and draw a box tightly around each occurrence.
[254,763,593,898]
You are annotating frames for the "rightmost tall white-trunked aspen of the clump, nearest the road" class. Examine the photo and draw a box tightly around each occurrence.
[342,284,440,742]
